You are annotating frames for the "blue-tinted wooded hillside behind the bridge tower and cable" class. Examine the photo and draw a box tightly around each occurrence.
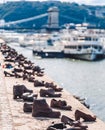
[0,1,105,29]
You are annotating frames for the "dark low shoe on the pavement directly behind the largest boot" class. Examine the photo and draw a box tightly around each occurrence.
[40,89,61,97]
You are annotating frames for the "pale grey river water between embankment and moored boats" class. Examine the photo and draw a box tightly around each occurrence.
[10,43,105,121]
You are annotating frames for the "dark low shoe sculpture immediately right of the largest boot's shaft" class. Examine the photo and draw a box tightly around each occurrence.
[50,99,72,110]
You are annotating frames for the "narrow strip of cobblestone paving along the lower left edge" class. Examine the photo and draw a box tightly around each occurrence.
[0,68,14,130]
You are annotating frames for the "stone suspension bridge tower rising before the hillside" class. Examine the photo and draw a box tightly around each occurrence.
[47,6,59,31]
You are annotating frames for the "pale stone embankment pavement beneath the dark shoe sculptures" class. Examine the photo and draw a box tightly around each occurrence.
[0,41,105,130]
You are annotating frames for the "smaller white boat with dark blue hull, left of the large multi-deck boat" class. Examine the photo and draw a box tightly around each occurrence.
[33,40,64,58]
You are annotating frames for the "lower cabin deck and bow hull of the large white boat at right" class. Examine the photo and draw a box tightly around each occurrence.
[64,43,104,61]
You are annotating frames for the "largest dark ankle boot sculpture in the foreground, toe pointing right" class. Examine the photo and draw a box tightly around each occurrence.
[32,99,61,118]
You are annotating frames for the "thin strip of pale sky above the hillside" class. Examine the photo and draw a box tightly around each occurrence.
[0,0,105,5]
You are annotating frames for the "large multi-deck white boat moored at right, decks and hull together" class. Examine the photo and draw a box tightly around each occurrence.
[63,25,104,61]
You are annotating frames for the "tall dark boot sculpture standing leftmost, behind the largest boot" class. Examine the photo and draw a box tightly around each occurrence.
[13,85,33,99]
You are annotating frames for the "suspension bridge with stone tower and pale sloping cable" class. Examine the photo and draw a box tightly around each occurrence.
[0,6,59,29]
